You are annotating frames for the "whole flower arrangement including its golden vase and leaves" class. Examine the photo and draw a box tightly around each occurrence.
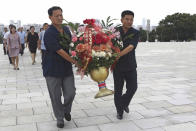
[60,17,123,98]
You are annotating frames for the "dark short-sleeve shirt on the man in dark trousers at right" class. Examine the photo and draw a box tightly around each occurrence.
[115,27,139,71]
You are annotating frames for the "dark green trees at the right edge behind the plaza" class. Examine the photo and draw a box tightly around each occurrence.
[156,13,196,41]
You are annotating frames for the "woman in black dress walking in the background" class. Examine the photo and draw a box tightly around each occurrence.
[27,26,39,65]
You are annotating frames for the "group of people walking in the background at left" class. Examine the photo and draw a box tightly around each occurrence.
[3,23,48,70]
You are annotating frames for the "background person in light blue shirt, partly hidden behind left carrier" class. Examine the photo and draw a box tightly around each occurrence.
[38,23,48,60]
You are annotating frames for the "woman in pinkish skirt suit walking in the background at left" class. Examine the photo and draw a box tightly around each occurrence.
[7,26,21,70]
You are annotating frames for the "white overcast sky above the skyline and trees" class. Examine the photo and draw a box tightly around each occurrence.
[0,0,196,25]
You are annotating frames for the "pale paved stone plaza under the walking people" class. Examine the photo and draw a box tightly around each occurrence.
[0,42,196,131]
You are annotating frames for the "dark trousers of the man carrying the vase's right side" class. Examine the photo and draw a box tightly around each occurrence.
[113,69,137,114]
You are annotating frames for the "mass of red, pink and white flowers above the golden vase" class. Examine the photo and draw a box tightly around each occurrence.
[70,19,122,75]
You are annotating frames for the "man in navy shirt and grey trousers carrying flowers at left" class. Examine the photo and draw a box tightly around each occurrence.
[42,6,76,128]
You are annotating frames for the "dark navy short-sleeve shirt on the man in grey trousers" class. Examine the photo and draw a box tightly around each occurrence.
[42,25,73,78]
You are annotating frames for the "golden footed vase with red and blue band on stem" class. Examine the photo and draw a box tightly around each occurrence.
[90,67,114,98]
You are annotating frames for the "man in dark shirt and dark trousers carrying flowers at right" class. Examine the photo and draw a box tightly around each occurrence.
[113,10,139,120]
